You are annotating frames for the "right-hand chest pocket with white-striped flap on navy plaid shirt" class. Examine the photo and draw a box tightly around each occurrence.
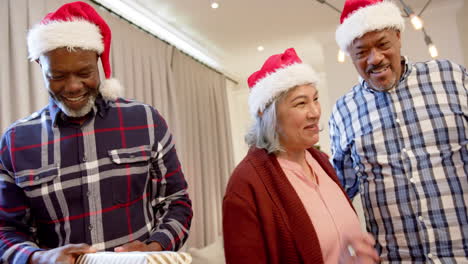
[108,145,151,204]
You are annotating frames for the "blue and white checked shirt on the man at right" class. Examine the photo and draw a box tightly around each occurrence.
[329,58,468,263]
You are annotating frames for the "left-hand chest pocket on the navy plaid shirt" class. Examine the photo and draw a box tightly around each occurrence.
[15,164,61,221]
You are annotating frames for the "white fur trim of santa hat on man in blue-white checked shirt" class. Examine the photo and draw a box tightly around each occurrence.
[335,1,405,53]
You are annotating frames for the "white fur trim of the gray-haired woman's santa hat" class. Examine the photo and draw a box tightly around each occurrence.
[249,63,319,118]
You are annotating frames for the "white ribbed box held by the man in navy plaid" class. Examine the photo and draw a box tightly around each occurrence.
[76,251,192,264]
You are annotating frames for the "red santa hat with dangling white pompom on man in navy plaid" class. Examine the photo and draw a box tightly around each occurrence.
[28,2,122,99]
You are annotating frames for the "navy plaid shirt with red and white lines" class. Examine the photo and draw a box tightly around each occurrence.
[0,97,192,263]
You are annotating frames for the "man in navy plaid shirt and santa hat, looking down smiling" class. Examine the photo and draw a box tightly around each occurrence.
[0,2,192,264]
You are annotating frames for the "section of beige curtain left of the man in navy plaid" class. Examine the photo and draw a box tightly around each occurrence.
[0,0,49,132]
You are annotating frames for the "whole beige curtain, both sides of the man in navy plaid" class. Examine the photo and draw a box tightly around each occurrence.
[0,0,233,250]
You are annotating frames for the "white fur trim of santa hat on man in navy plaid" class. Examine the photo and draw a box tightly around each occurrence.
[28,19,104,61]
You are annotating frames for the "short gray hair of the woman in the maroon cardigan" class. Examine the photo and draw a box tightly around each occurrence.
[245,92,287,153]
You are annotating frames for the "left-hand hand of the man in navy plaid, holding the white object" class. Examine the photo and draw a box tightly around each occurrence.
[29,244,96,264]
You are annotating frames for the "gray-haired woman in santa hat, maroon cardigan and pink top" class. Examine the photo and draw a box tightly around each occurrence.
[223,48,378,264]
